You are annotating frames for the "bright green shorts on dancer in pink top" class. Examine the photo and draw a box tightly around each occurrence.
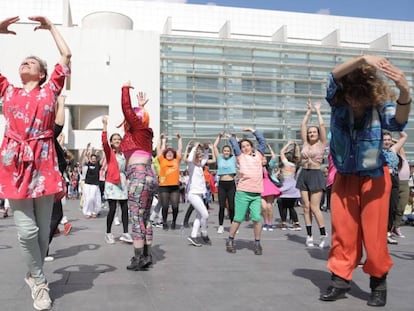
[233,191,262,222]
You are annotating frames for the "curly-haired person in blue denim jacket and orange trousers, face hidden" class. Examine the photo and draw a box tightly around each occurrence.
[320,55,411,307]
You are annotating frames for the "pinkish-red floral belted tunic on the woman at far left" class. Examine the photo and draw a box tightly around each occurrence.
[0,64,70,199]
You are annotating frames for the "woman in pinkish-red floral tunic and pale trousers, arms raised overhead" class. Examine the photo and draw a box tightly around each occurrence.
[0,16,71,310]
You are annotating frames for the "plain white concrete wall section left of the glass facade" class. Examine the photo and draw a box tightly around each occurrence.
[0,20,160,154]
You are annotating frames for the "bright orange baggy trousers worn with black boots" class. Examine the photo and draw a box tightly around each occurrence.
[327,168,392,281]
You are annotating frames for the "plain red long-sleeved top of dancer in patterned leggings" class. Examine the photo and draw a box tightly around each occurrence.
[121,86,154,154]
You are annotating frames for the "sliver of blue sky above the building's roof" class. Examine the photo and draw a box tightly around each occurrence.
[184,0,414,21]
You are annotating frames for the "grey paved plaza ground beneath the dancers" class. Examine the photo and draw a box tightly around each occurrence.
[0,200,414,311]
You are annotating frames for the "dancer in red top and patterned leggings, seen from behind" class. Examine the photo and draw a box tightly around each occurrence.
[121,82,157,271]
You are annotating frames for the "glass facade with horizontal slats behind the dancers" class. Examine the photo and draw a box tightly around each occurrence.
[160,35,414,159]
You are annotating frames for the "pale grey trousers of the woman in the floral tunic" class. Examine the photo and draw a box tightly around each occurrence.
[9,195,55,284]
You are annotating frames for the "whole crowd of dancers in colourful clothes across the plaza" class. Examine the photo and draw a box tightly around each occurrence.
[0,16,414,310]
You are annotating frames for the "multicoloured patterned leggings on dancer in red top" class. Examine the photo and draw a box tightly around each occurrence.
[127,163,158,245]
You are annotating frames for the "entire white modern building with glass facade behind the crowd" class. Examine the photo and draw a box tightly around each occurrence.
[0,0,414,160]
